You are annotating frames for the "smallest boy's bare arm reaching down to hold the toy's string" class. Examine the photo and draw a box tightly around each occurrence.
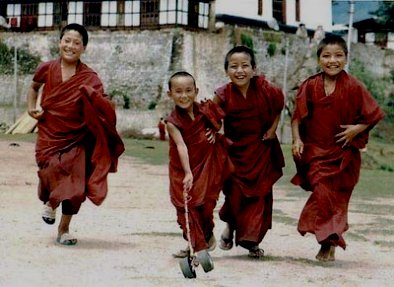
[167,123,193,191]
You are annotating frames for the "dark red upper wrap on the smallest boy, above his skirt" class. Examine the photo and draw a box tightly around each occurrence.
[167,100,232,207]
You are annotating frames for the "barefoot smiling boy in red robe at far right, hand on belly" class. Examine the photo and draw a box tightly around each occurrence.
[292,36,384,261]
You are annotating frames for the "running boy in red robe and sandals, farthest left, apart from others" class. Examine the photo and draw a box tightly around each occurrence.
[27,24,124,245]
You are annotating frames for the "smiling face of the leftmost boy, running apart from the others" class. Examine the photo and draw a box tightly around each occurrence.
[59,30,85,64]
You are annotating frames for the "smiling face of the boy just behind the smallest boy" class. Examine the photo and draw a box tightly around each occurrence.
[226,52,255,95]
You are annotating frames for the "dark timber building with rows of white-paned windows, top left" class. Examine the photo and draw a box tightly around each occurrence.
[0,0,211,32]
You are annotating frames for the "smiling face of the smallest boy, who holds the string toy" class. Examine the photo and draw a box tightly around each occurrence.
[167,75,198,114]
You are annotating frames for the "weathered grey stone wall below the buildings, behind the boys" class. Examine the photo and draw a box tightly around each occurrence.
[0,26,394,134]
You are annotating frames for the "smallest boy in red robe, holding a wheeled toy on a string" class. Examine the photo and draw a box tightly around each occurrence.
[167,72,232,257]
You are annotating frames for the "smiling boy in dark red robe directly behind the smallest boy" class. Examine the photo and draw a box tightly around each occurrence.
[214,46,284,258]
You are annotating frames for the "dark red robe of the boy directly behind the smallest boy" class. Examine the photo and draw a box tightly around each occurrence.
[215,76,284,247]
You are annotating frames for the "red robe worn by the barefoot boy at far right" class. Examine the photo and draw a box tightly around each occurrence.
[291,72,384,249]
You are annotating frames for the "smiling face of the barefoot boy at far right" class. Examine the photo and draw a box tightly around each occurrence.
[318,44,347,78]
